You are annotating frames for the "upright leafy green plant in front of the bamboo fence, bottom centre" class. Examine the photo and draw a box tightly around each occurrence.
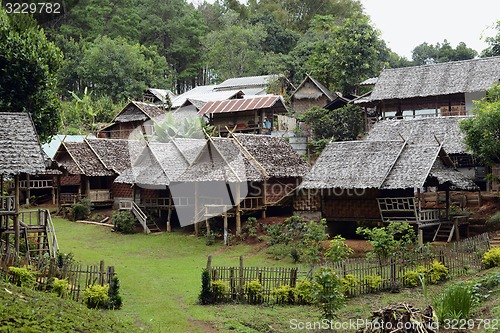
[313,267,345,320]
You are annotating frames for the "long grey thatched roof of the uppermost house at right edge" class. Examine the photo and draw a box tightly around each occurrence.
[370,57,500,102]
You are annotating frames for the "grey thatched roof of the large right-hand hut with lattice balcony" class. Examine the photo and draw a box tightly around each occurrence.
[301,140,471,190]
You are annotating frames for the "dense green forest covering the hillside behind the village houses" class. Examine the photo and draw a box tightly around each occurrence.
[0,0,500,137]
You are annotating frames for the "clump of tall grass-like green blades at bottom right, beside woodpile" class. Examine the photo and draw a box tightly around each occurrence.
[434,282,474,323]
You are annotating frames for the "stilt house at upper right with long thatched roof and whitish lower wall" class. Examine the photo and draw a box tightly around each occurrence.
[355,57,500,128]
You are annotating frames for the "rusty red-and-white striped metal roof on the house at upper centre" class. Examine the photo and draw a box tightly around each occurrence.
[198,95,286,115]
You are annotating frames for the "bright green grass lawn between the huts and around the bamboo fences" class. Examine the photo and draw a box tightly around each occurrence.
[53,218,499,333]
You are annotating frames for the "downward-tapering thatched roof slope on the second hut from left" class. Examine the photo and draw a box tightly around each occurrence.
[86,139,143,174]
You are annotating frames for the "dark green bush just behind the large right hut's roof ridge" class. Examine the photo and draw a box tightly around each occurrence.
[300,104,364,148]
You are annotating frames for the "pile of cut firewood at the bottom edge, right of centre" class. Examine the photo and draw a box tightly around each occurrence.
[357,303,438,333]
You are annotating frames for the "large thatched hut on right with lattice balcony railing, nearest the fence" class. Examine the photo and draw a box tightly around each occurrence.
[294,139,477,243]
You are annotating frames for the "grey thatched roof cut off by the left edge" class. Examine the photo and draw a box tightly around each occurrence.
[0,112,45,175]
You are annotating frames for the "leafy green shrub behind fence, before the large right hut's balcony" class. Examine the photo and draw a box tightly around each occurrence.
[356,222,416,263]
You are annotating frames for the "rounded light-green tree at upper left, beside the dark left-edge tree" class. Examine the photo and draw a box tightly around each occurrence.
[77,36,167,102]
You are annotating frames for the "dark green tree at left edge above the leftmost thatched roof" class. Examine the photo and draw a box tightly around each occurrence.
[0,9,62,142]
